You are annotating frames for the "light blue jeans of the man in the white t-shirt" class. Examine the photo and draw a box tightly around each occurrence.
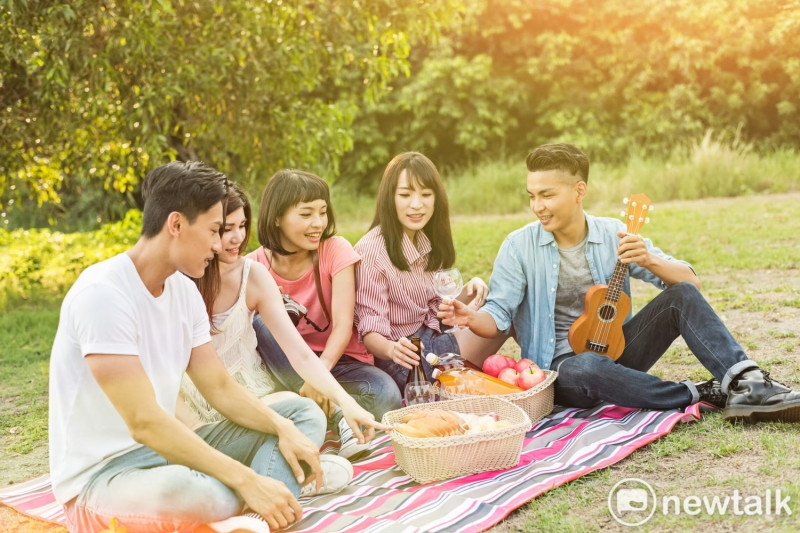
[64,397,325,533]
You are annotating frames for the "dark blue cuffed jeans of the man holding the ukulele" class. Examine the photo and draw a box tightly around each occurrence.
[550,283,757,409]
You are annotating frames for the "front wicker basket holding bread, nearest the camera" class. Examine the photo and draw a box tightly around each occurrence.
[382,396,531,483]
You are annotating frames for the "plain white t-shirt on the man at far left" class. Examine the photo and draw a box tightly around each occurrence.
[50,253,211,504]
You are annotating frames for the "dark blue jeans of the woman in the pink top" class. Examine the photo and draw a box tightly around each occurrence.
[253,316,400,427]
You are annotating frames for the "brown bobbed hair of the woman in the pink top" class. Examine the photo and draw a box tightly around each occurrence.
[258,169,336,255]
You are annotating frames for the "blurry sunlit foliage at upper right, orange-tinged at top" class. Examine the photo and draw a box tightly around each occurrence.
[343,0,800,188]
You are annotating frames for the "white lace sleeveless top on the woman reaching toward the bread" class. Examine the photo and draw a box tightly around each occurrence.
[180,258,276,423]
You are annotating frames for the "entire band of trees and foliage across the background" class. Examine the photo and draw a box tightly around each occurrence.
[0,0,800,224]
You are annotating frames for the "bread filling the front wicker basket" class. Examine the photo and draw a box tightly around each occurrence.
[395,409,511,438]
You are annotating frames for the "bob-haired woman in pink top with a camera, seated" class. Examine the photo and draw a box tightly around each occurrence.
[248,170,400,428]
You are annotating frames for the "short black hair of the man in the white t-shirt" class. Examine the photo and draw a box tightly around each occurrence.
[142,161,228,238]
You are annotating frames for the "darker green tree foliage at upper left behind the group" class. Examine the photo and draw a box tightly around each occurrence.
[0,0,458,227]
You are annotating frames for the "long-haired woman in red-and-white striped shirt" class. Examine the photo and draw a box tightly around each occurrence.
[355,152,504,390]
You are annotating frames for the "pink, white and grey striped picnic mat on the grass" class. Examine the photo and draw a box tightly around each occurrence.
[0,404,701,533]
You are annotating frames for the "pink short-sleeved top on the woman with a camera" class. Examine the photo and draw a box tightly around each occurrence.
[247,236,374,364]
